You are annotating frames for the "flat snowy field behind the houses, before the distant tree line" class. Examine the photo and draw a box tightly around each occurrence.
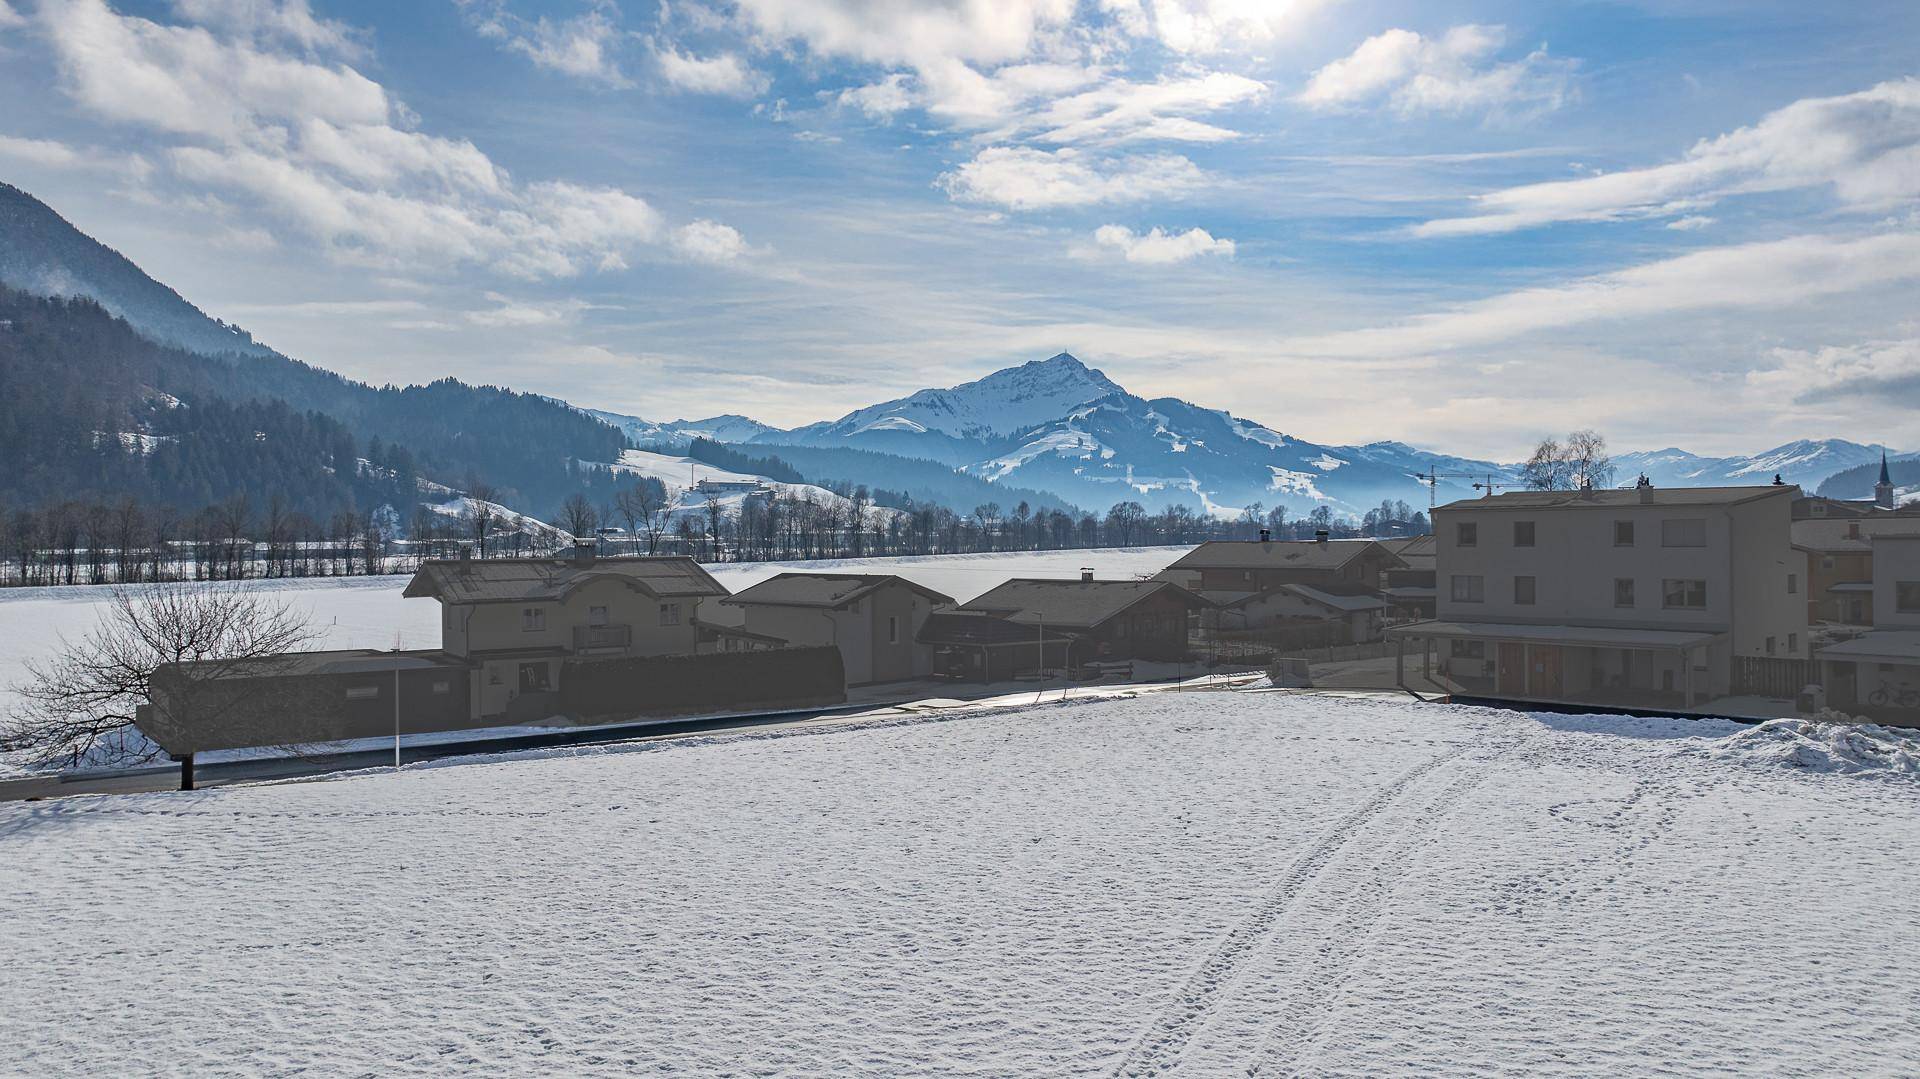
[0,547,1190,776]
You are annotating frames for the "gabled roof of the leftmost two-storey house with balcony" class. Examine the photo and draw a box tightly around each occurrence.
[403,555,728,603]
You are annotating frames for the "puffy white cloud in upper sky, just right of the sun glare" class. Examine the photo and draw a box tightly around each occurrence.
[1294,25,1572,115]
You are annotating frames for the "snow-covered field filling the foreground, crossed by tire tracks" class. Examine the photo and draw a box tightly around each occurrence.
[0,693,1920,1075]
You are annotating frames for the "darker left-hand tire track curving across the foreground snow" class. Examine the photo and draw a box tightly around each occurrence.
[1114,725,1519,1075]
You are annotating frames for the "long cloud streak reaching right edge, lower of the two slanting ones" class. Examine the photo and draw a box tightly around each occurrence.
[1286,232,1920,357]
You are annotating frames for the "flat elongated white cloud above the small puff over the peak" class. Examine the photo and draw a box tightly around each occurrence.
[939,146,1206,209]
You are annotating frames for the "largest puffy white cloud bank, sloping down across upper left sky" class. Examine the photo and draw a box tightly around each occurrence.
[29,0,741,278]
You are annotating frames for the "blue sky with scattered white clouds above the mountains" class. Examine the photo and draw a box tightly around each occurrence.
[0,0,1920,455]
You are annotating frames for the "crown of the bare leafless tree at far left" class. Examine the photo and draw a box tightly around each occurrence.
[0,584,317,764]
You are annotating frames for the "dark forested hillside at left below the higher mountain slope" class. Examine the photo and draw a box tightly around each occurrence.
[0,288,624,516]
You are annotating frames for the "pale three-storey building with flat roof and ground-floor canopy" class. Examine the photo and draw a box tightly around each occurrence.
[1388,484,1807,707]
